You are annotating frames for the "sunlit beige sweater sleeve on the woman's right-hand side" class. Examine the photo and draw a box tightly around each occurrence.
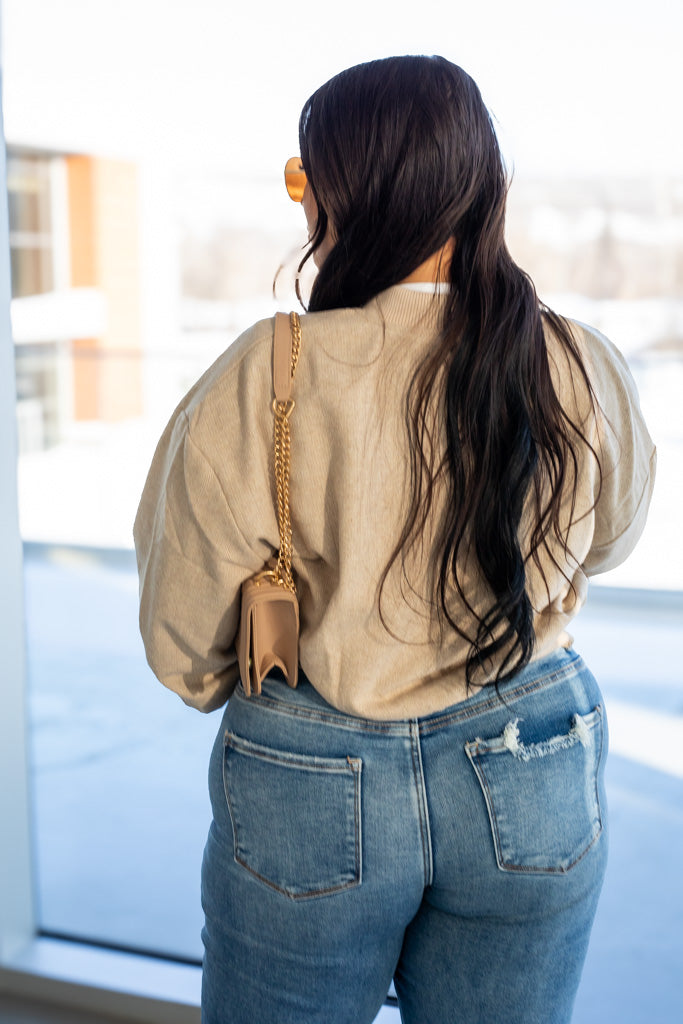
[583,328,656,575]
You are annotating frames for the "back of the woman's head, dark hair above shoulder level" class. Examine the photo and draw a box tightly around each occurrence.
[299,56,506,310]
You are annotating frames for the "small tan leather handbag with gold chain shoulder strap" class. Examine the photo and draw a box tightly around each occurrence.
[237,312,301,696]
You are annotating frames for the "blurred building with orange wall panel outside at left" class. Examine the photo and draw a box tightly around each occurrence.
[7,146,142,453]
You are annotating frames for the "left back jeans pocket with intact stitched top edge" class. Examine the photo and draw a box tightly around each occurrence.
[223,732,361,899]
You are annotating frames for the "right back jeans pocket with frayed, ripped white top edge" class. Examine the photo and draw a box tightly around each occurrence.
[465,706,603,873]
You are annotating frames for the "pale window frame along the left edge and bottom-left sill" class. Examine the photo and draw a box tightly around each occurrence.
[0,54,201,1024]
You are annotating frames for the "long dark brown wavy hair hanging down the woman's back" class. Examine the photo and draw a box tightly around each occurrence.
[299,56,597,684]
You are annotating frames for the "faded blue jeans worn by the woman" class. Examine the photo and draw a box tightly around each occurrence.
[202,650,607,1024]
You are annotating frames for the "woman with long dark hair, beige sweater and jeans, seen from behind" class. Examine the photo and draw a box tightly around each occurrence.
[135,57,654,1024]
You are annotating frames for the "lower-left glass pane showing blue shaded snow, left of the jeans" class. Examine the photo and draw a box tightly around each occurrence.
[25,543,216,961]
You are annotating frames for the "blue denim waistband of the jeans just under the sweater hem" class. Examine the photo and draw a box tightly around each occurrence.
[231,647,588,736]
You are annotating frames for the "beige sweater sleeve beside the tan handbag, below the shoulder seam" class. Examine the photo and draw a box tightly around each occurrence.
[133,410,255,712]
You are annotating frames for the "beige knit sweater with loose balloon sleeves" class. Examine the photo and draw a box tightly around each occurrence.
[134,286,655,719]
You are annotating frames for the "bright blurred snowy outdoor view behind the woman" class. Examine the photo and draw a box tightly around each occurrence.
[2,0,683,1024]
